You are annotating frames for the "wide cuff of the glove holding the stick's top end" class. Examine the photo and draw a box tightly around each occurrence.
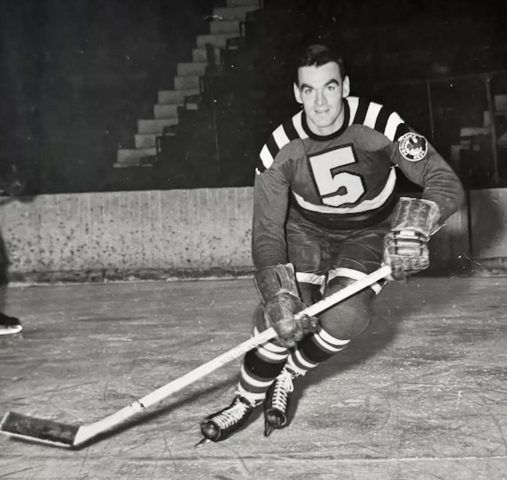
[391,197,440,239]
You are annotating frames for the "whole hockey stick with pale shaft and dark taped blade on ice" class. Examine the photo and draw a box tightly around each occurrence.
[0,266,391,448]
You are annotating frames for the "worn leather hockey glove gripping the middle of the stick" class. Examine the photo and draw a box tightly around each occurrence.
[255,263,317,348]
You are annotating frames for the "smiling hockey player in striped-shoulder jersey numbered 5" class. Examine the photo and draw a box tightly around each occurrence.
[197,45,464,441]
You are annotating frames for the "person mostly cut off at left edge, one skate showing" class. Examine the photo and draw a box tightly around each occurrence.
[0,157,26,335]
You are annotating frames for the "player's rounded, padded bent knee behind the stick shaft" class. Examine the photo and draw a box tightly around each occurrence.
[318,277,375,340]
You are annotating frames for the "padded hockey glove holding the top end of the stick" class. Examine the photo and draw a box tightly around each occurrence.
[384,197,440,282]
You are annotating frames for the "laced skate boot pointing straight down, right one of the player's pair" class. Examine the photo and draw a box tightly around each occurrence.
[264,366,300,437]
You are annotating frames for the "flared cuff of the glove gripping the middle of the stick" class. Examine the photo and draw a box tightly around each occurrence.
[254,263,299,303]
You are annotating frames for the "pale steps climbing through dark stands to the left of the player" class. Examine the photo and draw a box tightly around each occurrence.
[114,0,260,168]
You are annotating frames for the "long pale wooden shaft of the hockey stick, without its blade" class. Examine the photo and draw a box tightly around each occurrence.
[90,266,391,434]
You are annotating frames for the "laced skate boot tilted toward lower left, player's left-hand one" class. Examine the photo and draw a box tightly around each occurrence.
[198,393,258,445]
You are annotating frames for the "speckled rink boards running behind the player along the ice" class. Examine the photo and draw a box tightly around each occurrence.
[0,187,507,281]
